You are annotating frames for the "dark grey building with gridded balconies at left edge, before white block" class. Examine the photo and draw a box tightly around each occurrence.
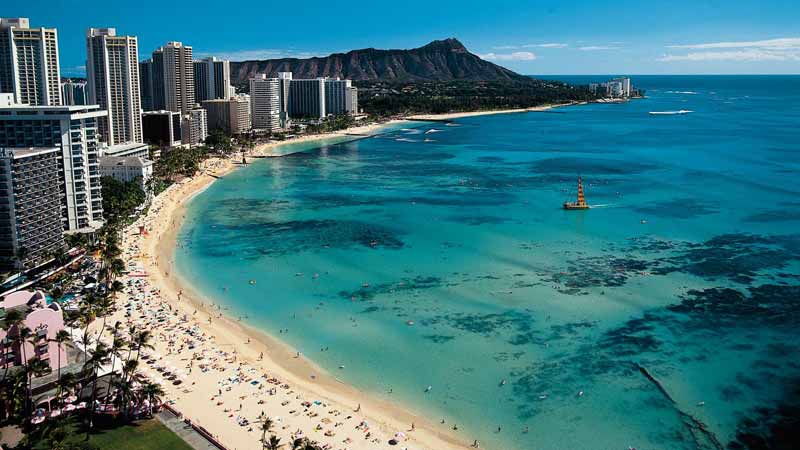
[0,147,64,271]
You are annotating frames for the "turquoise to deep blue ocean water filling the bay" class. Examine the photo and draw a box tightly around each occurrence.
[175,76,800,450]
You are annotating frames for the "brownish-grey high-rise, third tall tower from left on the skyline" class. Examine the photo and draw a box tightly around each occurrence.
[152,42,196,113]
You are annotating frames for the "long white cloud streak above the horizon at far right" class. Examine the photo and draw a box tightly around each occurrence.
[658,38,800,62]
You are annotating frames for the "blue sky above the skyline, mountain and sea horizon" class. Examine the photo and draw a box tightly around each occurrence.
[6,0,800,75]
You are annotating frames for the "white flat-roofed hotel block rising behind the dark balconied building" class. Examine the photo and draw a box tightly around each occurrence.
[0,105,108,232]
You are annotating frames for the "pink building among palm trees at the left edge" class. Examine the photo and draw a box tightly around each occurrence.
[0,291,67,371]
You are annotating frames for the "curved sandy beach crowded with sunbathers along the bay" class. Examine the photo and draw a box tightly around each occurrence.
[98,124,473,450]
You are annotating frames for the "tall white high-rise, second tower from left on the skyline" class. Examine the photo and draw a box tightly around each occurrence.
[86,28,142,145]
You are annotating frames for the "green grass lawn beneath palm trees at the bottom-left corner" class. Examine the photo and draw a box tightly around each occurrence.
[29,419,192,450]
